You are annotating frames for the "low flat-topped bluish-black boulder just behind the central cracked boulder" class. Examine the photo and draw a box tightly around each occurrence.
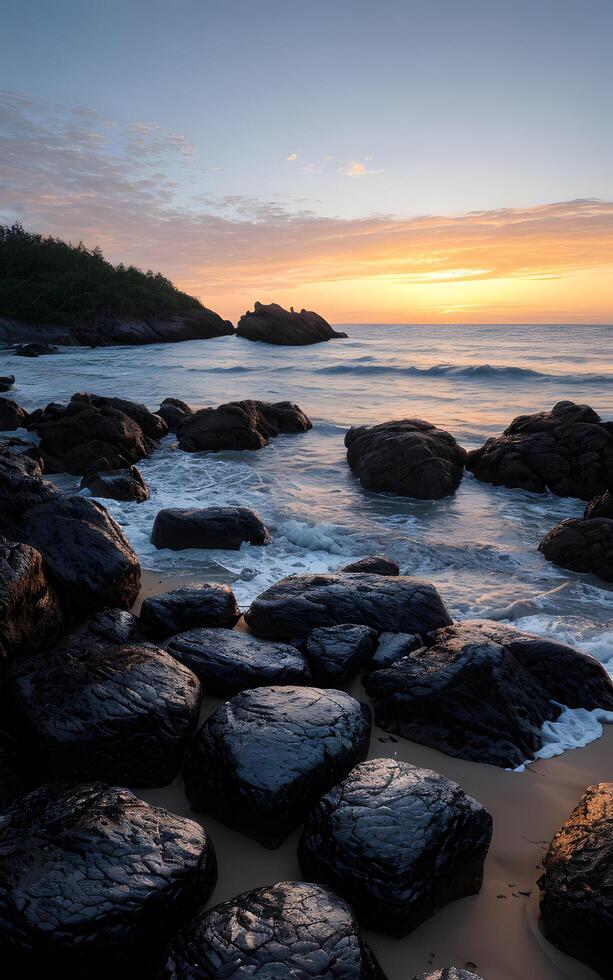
[168,629,311,698]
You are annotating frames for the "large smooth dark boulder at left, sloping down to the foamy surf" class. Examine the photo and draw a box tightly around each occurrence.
[14,498,140,619]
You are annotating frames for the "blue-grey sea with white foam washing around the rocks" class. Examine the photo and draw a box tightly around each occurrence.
[2,324,613,754]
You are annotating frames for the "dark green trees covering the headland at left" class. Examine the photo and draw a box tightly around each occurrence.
[0,224,202,325]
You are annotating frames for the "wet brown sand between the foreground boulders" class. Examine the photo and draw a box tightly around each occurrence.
[135,573,613,980]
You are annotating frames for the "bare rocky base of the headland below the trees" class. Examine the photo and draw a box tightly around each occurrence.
[0,308,234,347]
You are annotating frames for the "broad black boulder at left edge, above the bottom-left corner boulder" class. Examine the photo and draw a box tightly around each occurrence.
[7,636,201,786]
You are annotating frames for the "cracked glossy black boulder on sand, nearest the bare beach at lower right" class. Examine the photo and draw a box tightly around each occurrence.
[298,759,492,936]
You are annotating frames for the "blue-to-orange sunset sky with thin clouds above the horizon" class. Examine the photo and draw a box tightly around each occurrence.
[0,0,613,323]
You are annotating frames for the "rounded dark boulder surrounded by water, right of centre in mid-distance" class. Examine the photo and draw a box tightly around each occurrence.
[345,419,466,500]
